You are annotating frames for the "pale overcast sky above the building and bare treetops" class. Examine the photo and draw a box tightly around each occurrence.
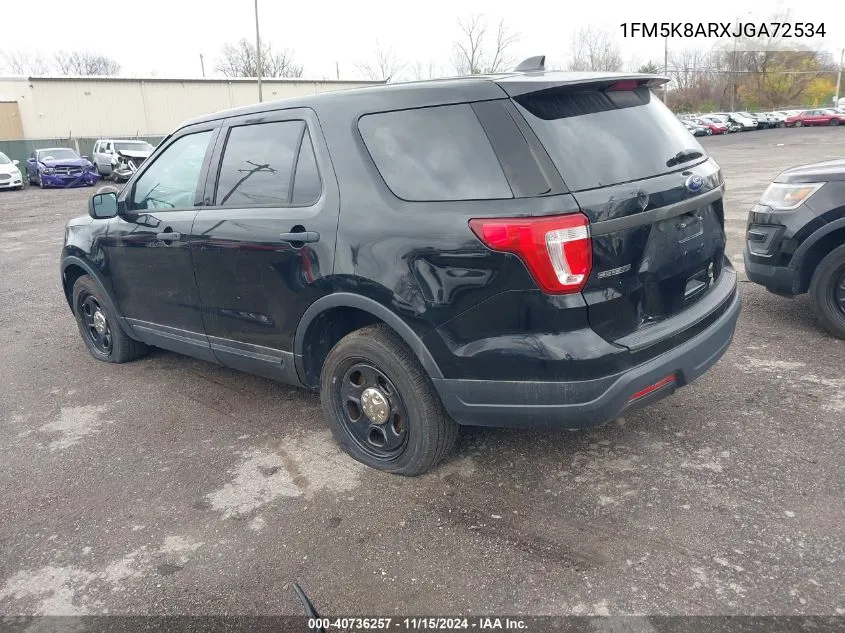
[0,0,845,79]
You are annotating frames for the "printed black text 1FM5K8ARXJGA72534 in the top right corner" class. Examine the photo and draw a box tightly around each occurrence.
[619,22,825,39]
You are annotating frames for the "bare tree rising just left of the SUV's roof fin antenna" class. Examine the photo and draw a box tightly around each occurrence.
[452,15,519,75]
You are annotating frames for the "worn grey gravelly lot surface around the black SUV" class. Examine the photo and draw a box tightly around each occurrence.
[0,128,845,615]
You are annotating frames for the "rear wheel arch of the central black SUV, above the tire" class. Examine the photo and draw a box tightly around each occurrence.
[293,292,443,388]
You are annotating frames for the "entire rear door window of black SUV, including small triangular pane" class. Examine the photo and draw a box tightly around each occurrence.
[215,121,321,207]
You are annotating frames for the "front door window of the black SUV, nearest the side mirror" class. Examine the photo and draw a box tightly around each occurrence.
[131,131,211,209]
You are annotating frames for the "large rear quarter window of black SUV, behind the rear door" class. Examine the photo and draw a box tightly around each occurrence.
[358,104,513,200]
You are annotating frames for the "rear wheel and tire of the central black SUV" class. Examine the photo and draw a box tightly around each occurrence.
[320,325,458,476]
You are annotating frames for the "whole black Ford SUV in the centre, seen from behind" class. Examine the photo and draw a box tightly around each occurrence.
[61,61,740,475]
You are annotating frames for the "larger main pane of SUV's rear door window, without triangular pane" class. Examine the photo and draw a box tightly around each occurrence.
[216,121,305,207]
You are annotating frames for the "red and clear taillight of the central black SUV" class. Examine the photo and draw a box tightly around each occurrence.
[469,213,593,294]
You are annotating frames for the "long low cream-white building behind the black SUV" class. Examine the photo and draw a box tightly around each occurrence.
[0,77,383,141]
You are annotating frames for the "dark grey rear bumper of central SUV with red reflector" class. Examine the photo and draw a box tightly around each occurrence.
[434,292,741,429]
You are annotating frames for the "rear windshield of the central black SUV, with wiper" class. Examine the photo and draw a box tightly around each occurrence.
[515,88,707,191]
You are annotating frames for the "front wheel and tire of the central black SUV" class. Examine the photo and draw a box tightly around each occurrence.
[73,275,148,363]
